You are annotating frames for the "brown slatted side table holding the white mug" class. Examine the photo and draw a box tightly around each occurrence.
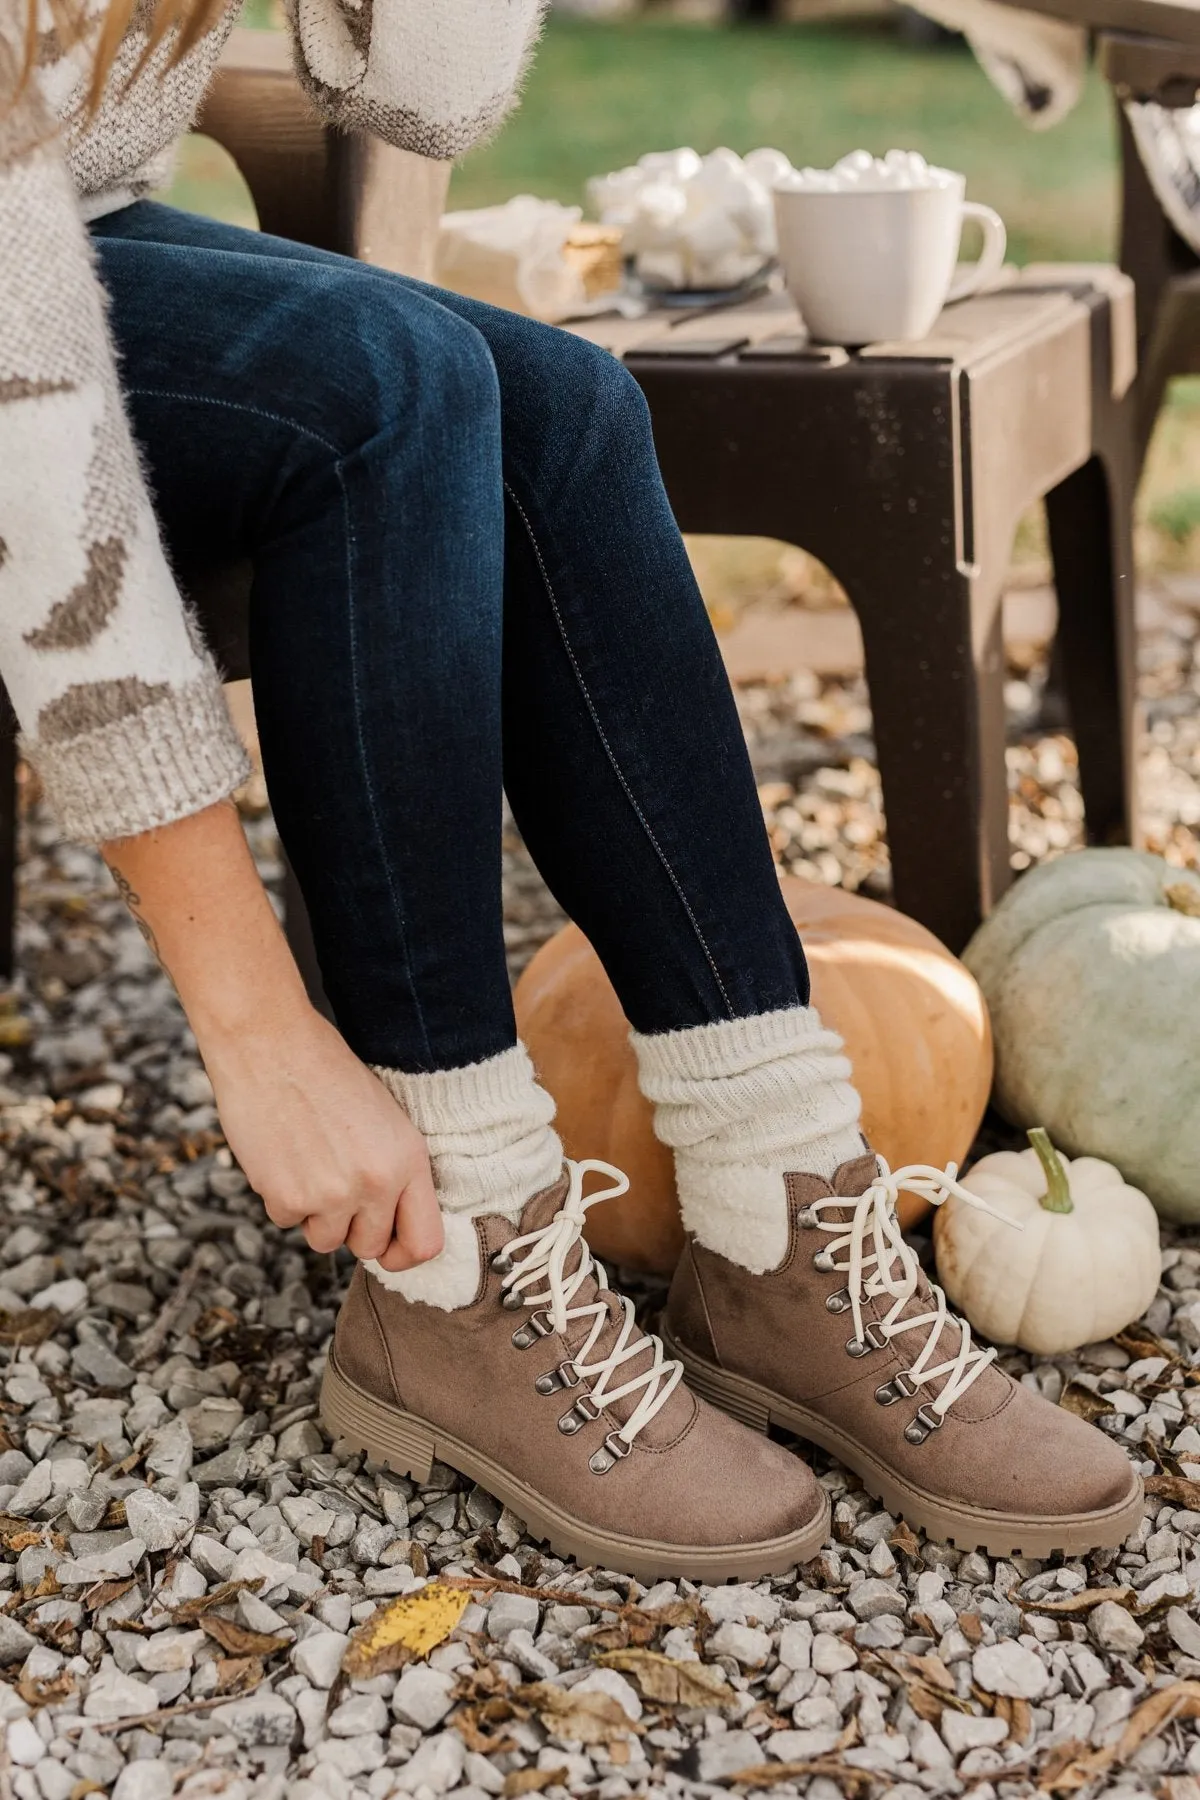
[578,266,1135,950]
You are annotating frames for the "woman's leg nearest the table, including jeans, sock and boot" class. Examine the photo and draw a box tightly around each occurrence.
[372,288,1141,1553]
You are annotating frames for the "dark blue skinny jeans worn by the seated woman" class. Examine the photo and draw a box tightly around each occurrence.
[94,202,808,1071]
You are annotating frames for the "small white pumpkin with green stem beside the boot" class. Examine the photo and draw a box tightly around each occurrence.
[934,1127,1162,1355]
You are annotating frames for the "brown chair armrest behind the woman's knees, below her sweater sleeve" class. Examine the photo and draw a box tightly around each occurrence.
[196,29,450,279]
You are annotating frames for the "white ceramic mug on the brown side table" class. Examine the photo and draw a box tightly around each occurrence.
[775,169,1007,344]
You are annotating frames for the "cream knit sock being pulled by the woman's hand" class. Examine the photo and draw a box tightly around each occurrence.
[365,1044,563,1312]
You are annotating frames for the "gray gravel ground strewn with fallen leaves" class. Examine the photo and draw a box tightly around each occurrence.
[0,625,1200,1800]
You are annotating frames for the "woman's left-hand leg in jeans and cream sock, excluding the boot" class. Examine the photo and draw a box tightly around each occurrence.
[95,203,561,1213]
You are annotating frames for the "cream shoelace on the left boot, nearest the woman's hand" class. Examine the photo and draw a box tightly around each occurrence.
[493,1157,684,1474]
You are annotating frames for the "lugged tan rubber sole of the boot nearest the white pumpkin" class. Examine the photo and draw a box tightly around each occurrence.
[658,1327,1144,1557]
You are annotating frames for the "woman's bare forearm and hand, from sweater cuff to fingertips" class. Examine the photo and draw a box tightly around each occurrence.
[103,805,444,1271]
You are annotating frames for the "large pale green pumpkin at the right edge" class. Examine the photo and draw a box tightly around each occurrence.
[964,850,1200,1222]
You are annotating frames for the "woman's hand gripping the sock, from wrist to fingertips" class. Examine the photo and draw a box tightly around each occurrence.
[200,1003,444,1269]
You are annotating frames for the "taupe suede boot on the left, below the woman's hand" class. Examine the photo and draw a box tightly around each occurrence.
[320,1163,829,1580]
